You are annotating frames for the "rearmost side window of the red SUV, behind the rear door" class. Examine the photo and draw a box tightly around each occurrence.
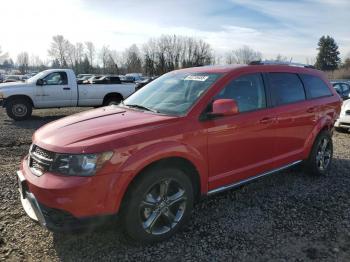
[300,74,332,98]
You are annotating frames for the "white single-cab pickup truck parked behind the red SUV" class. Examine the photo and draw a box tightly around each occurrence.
[0,69,135,120]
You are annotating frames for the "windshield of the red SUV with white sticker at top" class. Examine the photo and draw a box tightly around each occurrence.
[123,72,221,116]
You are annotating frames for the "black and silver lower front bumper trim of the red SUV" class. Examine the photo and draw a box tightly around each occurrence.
[17,171,116,232]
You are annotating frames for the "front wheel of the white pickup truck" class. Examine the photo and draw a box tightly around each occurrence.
[6,98,33,121]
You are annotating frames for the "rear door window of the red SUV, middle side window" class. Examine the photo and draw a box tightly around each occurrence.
[269,73,306,105]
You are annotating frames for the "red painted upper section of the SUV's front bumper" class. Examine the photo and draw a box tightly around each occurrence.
[20,157,118,218]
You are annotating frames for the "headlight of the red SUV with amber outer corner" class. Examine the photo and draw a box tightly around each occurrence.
[51,152,113,176]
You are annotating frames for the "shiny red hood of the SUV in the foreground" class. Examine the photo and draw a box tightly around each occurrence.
[33,106,178,153]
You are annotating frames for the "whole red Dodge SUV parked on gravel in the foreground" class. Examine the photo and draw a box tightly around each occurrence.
[17,63,341,242]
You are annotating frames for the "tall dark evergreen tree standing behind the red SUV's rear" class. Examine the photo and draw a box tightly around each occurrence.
[315,36,340,71]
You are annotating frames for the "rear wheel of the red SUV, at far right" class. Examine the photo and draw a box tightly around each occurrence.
[305,131,333,176]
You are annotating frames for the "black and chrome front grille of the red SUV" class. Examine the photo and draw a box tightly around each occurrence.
[28,144,55,176]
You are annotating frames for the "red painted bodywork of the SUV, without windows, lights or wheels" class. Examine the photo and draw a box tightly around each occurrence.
[21,65,341,217]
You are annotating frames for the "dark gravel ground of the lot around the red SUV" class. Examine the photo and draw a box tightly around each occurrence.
[0,108,350,261]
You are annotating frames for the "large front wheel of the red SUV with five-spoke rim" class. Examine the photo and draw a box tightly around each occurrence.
[121,168,194,244]
